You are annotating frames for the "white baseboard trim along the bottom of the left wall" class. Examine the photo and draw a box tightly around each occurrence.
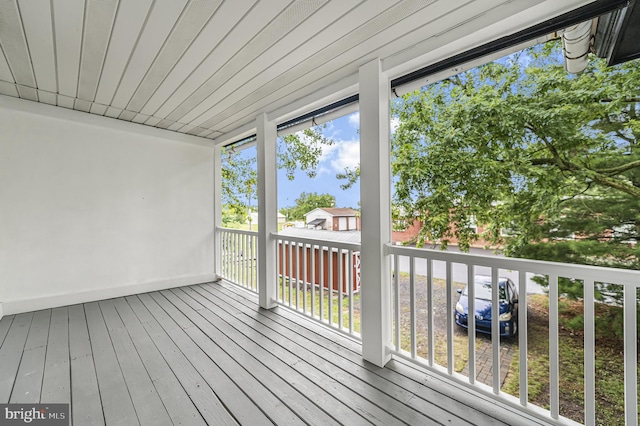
[0,274,217,318]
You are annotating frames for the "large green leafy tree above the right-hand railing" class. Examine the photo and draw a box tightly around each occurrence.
[392,42,640,268]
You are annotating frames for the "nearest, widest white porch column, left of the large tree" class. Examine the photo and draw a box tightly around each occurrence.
[360,59,391,367]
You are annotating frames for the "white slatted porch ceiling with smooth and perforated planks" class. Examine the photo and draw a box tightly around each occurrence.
[0,0,590,145]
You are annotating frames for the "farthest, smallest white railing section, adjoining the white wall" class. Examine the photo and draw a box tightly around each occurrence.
[217,228,259,293]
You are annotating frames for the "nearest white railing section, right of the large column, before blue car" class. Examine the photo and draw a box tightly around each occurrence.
[384,245,640,425]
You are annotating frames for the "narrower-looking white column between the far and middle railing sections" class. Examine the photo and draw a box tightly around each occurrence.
[256,113,278,309]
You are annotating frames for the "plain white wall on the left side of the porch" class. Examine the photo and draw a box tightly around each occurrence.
[0,96,214,315]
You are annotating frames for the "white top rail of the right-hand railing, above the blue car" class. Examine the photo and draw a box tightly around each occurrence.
[385,244,640,287]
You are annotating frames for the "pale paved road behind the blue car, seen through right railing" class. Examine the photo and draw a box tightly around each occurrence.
[400,246,544,294]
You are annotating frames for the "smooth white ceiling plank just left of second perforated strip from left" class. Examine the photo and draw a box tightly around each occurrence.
[52,0,84,97]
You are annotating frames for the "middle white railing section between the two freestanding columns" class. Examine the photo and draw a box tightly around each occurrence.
[272,234,360,338]
